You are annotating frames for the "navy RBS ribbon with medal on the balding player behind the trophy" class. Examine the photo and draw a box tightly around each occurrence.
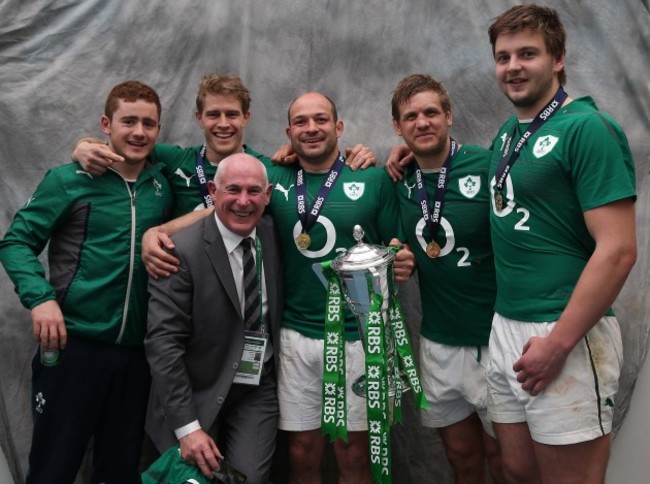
[296,153,345,249]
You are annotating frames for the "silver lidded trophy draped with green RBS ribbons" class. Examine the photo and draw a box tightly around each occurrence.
[332,225,408,398]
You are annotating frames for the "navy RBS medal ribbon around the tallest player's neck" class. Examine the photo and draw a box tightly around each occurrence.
[494,86,568,211]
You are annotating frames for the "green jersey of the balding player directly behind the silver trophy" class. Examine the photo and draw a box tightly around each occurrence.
[268,165,401,340]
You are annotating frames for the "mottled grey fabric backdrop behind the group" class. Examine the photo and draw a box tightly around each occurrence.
[0,0,650,482]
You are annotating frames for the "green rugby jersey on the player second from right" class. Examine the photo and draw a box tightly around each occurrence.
[396,145,496,346]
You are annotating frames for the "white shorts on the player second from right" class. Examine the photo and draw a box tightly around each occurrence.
[420,338,494,437]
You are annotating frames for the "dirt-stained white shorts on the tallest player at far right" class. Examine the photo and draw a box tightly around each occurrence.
[487,314,623,445]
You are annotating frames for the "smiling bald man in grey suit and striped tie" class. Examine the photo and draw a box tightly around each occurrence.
[145,153,283,484]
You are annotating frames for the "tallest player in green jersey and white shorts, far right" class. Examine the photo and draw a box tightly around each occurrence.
[488,5,636,483]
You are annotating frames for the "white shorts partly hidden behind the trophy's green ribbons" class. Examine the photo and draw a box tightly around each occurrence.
[278,328,368,432]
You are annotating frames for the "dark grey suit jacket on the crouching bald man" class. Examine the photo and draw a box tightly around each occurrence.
[144,216,283,452]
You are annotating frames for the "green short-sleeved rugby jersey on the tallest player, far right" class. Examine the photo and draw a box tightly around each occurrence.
[490,97,635,322]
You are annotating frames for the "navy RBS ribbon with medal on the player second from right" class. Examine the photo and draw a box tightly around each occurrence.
[415,137,458,258]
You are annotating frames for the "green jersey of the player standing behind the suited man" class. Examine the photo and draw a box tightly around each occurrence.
[151,144,271,218]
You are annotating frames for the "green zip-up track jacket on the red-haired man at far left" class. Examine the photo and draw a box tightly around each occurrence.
[0,163,173,346]
